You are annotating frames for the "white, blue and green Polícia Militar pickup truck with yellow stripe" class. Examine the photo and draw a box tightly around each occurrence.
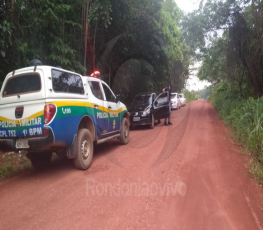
[0,60,129,170]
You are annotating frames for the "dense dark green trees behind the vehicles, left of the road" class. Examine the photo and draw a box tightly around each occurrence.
[0,0,189,105]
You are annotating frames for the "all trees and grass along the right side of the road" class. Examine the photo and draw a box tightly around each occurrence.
[182,0,263,181]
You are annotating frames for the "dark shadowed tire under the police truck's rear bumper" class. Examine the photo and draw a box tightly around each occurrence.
[30,152,52,170]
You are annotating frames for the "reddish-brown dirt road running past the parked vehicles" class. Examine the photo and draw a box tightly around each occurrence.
[0,101,263,230]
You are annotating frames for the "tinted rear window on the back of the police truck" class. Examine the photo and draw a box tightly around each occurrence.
[3,74,41,97]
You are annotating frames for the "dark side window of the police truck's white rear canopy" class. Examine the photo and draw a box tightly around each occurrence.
[52,69,84,94]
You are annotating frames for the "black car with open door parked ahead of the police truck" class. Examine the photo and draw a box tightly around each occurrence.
[129,92,169,129]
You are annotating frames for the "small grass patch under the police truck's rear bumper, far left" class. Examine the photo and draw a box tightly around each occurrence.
[0,152,31,181]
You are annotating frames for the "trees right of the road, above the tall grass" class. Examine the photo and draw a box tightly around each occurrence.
[184,0,263,98]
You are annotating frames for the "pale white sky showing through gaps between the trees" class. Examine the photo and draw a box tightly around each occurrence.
[175,0,210,91]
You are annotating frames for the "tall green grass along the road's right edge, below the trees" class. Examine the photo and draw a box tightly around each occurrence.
[210,83,263,184]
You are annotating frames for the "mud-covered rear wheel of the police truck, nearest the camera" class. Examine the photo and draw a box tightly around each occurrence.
[74,129,93,170]
